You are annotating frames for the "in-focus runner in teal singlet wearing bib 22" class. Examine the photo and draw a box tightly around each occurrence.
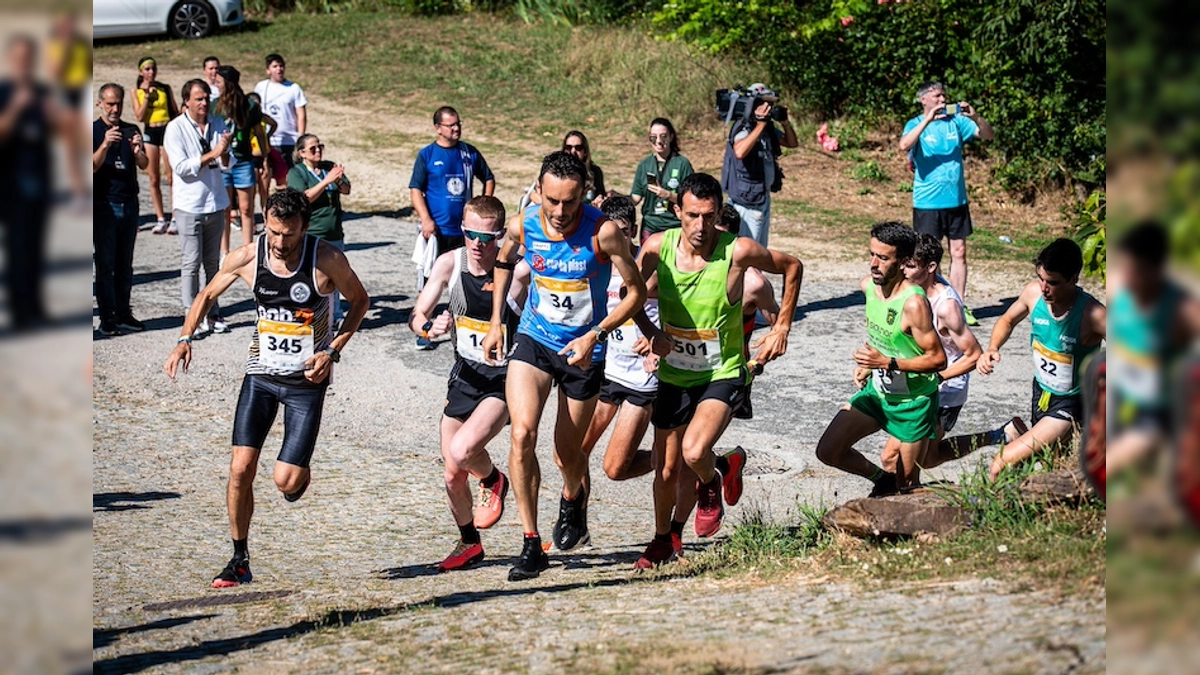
[977,239,1108,478]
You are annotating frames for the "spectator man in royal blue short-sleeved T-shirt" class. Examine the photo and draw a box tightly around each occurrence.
[408,106,496,253]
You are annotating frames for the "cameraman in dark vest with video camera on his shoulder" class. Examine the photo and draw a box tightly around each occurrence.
[721,84,800,246]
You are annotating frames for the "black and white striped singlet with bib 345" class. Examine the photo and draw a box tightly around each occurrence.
[246,235,334,386]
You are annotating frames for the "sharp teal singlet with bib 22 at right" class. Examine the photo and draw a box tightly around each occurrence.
[1030,288,1099,396]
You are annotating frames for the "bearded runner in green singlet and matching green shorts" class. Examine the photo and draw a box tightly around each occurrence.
[817,222,946,497]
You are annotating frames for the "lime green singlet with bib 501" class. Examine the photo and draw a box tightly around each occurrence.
[658,227,746,387]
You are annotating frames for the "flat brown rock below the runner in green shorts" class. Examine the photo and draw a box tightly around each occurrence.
[824,491,967,537]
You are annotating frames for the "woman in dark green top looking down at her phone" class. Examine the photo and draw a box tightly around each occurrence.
[630,118,695,244]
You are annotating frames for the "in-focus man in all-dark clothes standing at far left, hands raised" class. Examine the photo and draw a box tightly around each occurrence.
[91,83,150,335]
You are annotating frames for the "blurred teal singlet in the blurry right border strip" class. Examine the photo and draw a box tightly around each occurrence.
[1108,283,1182,408]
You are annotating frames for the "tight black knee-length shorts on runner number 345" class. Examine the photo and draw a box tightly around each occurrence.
[233,375,328,467]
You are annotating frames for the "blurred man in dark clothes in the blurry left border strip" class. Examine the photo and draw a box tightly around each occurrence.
[0,35,59,330]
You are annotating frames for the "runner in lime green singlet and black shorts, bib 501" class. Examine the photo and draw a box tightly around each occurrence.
[635,173,804,569]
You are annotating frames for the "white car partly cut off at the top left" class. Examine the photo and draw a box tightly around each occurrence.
[91,0,246,37]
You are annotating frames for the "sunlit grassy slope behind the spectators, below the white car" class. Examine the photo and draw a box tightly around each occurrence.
[95,12,752,142]
